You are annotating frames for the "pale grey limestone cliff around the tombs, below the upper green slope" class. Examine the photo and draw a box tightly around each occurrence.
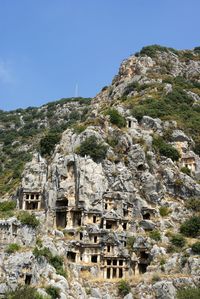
[4,116,200,299]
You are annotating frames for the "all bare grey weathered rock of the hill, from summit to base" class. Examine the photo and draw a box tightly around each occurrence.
[0,46,200,299]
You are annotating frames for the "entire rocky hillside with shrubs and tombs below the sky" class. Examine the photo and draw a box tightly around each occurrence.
[0,46,200,299]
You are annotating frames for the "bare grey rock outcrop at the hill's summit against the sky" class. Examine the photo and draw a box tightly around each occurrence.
[97,47,200,102]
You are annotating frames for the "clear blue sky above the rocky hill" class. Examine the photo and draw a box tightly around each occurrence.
[0,0,200,110]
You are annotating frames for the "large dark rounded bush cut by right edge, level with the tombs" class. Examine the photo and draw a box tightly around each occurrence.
[180,215,200,238]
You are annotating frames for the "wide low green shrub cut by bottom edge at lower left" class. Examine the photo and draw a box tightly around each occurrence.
[5,285,50,299]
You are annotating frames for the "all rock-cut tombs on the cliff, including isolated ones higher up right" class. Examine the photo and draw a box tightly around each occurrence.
[11,117,196,279]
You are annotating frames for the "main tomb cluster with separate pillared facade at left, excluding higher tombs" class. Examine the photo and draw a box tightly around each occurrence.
[17,190,153,279]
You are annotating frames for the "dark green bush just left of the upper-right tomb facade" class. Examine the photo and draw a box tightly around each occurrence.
[153,136,180,161]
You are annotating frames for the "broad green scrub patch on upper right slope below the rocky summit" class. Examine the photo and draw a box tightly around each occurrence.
[130,86,200,159]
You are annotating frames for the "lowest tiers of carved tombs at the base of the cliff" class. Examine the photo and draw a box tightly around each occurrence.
[67,231,151,279]
